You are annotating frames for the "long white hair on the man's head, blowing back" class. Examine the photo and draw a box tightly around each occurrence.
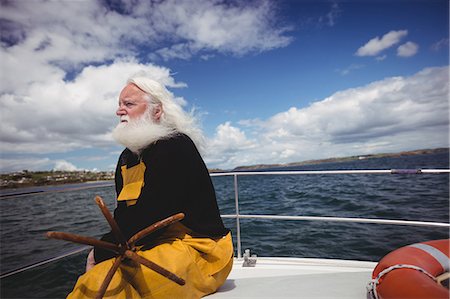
[127,76,205,151]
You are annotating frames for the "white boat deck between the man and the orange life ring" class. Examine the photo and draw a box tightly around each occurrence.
[207,257,376,299]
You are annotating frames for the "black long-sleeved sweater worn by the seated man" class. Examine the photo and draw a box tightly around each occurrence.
[95,134,229,262]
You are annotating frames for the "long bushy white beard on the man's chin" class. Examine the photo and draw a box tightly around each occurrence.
[112,113,176,154]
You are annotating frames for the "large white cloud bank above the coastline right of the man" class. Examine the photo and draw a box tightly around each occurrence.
[207,67,449,169]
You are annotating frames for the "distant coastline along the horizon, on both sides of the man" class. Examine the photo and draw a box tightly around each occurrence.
[0,148,450,190]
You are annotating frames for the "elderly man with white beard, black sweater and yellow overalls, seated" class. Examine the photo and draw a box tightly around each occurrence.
[69,77,233,298]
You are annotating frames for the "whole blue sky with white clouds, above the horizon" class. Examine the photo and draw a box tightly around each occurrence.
[0,0,449,172]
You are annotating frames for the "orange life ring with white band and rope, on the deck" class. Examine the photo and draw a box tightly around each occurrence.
[369,239,450,299]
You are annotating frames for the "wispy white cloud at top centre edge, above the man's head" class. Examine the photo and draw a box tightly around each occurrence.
[151,0,292,60]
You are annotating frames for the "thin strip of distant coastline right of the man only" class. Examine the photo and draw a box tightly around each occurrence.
[210,147,450,172]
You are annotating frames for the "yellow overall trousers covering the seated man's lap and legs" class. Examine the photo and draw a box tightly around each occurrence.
[67,223,233,298]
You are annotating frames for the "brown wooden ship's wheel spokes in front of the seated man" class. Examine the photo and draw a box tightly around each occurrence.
[46,196,185,298]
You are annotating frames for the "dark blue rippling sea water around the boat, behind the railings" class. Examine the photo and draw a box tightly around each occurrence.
[0,153,449,298]
